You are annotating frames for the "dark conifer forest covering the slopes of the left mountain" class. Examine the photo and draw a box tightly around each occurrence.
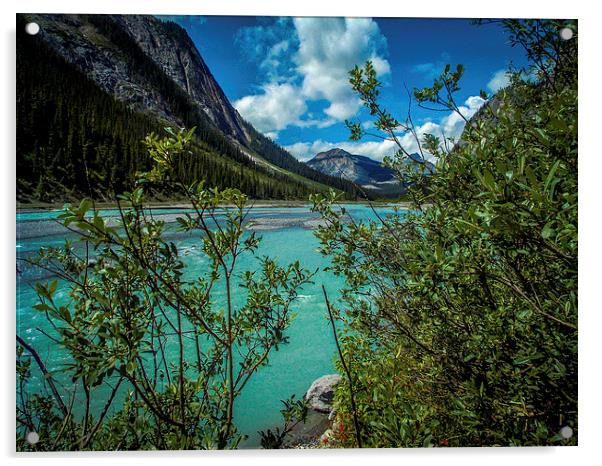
[17,15,357,202]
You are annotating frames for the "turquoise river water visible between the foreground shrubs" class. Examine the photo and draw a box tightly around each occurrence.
[17,205,400,448]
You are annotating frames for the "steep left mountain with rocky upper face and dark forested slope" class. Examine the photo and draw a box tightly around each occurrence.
[17,14,358,201]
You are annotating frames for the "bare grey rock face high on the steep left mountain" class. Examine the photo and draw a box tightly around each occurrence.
[27,14,250,146]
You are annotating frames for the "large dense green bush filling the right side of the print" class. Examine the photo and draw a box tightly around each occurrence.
[314,20,578,447]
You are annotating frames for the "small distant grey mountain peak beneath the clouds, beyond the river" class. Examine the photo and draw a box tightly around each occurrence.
[306,148,434,195]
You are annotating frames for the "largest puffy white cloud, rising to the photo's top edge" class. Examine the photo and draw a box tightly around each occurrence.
[234,18,391,137]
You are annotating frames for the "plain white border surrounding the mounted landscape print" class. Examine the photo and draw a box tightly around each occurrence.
[0,0,602,466]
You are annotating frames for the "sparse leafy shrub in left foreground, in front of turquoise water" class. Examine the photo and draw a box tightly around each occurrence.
[17,131,311,451]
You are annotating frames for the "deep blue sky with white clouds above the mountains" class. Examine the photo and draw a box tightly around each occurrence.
[156,16,525,160]
